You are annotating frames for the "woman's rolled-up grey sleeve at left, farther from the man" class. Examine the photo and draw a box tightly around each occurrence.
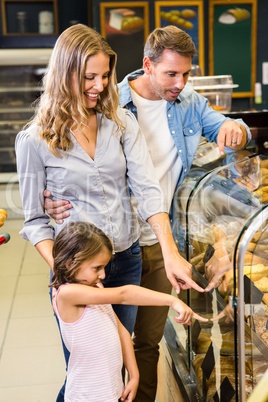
[15,129,54,245]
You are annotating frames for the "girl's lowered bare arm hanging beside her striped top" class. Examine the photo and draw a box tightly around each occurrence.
[115,314,140,402]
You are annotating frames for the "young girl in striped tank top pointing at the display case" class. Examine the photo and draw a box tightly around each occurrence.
[50,222,207,402]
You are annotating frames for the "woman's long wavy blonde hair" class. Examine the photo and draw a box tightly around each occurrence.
[33,24,122,156]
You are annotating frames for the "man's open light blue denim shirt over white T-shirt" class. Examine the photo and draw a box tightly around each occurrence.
[118,69,251,201]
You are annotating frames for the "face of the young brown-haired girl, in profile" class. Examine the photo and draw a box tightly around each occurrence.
[75,249,111,287]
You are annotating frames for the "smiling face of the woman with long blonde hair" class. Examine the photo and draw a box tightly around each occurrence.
[72,53,110,109]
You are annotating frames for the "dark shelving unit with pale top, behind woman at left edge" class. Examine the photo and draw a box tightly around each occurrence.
[0,49,52,173]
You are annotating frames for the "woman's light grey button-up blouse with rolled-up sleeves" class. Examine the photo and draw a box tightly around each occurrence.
[15,108,168,252]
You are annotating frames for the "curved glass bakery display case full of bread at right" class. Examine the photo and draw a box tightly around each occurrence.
[165,151,268,402]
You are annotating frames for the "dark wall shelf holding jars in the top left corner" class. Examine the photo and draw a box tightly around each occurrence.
[1,0,59,36]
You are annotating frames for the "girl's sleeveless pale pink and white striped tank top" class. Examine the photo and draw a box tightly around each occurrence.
[53,285,124,402]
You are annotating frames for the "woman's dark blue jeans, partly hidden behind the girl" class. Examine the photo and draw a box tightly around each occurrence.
[50,240,142,402]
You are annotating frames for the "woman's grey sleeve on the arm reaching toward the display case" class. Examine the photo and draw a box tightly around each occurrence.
[121,109,168,221]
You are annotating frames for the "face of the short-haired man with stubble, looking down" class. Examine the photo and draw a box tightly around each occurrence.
[144,49,192,102]
